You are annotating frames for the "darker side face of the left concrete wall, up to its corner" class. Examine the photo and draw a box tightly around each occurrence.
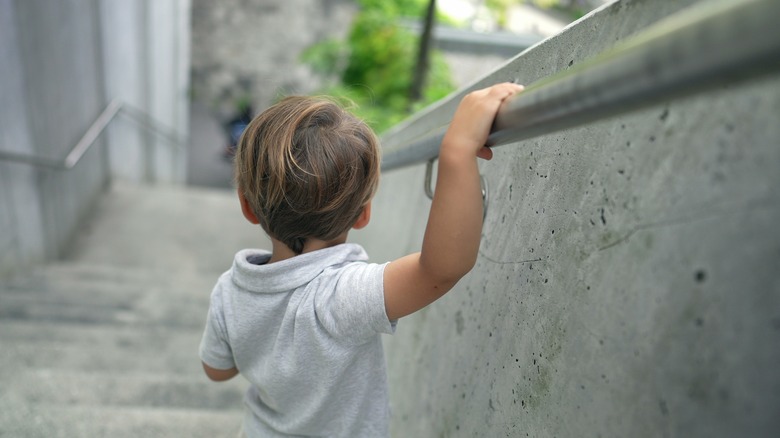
[0,0,108,270]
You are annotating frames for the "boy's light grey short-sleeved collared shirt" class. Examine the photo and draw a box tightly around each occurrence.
[200,244,395,437]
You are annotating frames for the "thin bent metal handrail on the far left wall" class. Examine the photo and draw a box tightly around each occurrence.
[0,99,183,170]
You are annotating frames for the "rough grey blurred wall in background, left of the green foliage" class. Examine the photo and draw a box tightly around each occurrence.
[192,0,356,119]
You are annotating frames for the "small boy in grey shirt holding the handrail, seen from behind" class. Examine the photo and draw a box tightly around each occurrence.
[200,83,522,437]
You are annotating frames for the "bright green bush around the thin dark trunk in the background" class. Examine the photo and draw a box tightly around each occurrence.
[302,0,455,132]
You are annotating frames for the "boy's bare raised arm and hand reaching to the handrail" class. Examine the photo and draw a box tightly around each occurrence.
[384,83,522,320]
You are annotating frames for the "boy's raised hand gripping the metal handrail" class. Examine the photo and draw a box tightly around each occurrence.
[441,82,523,160]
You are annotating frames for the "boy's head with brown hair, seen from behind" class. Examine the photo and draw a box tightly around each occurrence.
[235,96,379,254]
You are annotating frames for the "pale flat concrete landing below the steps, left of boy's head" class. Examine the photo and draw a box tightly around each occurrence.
[64,183,270,274]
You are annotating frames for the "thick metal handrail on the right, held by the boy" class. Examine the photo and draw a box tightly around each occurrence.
[382,0,780,171]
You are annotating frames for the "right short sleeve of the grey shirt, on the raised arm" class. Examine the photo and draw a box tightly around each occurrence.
[315,262,395,344]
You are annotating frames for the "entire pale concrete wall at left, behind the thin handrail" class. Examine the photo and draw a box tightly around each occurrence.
[0,0,189,275]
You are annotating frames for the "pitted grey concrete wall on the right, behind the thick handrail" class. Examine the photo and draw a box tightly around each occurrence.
[351,0,780,437]
